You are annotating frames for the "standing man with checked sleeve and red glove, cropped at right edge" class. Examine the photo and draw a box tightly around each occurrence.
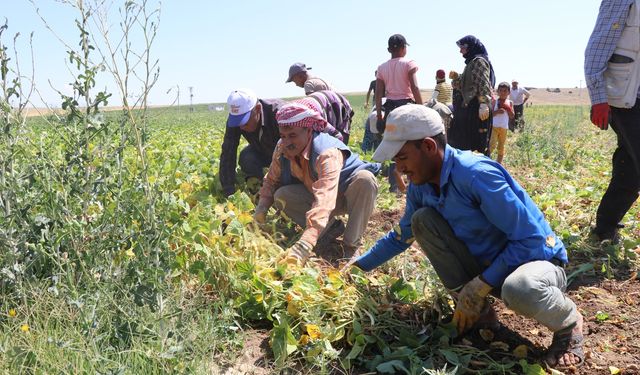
[584,0,640,243]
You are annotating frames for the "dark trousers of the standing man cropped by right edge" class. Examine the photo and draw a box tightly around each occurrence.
[596,100,640,233]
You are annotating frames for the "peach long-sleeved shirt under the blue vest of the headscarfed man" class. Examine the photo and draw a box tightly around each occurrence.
[256,139,344,245]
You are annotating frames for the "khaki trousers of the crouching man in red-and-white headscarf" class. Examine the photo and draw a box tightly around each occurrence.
[273,170,378,247]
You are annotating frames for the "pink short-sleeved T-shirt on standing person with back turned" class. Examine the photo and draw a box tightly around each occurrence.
[376,57,418,100]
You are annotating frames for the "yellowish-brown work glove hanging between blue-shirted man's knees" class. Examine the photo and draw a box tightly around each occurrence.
[453,276,493,334]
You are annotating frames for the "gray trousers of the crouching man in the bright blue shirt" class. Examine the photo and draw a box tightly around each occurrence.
[411,207,578,332]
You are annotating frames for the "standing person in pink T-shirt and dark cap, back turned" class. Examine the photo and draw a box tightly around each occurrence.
[375,34,422,192]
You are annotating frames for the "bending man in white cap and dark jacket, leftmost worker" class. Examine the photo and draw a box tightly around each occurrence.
[220,89,284,196]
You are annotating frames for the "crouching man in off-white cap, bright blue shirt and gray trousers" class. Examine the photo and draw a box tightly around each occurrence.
[354,104,584,367]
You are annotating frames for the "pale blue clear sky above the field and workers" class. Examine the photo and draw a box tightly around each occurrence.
[0,0,600,107]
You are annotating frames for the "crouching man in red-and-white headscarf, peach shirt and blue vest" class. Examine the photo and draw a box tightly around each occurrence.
[254,102,380,263]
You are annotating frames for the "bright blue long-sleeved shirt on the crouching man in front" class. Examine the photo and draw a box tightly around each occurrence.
[357,146,568,287]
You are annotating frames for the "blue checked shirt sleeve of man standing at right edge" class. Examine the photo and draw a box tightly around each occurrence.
[584,0,640,104]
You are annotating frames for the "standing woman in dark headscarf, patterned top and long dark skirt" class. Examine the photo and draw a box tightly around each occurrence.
[447,35,495,155]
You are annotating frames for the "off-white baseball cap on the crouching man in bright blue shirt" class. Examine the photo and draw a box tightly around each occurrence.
[373,104,444,161]
